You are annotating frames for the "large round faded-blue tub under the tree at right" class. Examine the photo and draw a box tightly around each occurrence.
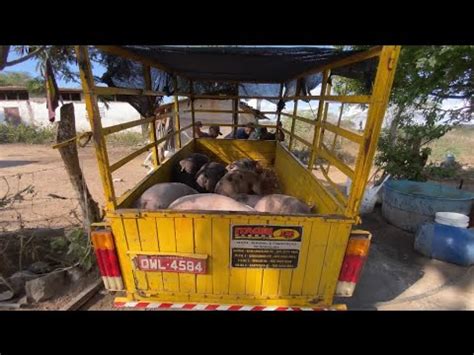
[382,180,474,232]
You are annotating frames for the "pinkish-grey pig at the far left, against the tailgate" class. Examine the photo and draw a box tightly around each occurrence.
[132,182,198,210]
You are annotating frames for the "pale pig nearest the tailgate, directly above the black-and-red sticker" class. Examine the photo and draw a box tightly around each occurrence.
[255,194,311,214]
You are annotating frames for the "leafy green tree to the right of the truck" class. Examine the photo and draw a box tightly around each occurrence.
[335,46,474,180]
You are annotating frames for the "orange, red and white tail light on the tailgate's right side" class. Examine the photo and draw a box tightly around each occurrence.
[336,230,372,297]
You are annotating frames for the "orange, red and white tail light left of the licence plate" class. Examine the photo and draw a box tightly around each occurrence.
[91,229,123,291]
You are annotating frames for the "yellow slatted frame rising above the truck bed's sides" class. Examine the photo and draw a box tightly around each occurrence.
[76,46,400,217]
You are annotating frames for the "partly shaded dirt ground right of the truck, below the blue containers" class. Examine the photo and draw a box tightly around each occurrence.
[336,208,474,310]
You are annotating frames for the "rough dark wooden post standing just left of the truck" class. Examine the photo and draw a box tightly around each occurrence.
[56,103,102,233]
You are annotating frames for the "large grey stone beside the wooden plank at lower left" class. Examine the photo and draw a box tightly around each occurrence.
[25,271,66,303]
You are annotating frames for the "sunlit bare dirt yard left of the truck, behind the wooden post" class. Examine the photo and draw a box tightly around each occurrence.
[0,144,147,232]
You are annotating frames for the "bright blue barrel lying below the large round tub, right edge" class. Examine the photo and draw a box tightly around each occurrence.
[414,223,474,266]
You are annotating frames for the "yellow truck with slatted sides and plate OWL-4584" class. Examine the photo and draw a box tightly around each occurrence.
[76,46,400,311]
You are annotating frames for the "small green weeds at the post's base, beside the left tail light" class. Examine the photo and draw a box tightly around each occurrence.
[50,228,95,271]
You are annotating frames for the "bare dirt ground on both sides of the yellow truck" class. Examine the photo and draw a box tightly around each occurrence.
[0,144,474,310]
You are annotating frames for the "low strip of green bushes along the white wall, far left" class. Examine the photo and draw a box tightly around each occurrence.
[0,124,56,144]
